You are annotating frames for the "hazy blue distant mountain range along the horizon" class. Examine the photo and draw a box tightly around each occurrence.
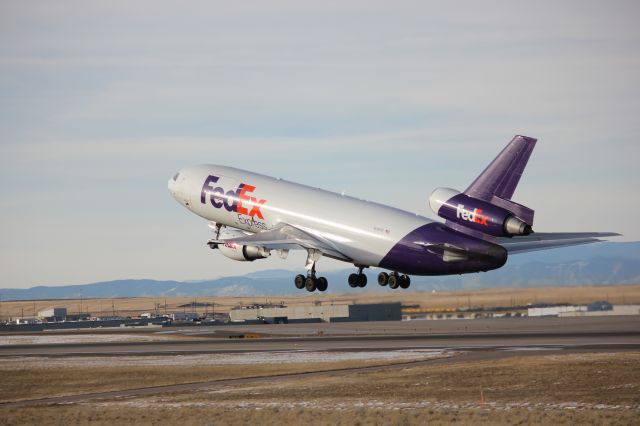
[0,242,640,300]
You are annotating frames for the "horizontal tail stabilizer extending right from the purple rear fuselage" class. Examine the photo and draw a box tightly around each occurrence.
[496,232,620,254]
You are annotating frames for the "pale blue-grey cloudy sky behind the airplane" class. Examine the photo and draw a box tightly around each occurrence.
[0,0,640,288]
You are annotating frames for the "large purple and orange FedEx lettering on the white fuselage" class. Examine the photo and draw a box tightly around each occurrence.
[200,175,266,219]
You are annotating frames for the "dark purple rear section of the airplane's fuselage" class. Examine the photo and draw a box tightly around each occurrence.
[379,223,507,275]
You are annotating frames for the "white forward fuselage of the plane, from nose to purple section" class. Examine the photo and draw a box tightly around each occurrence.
[169,165,432,266]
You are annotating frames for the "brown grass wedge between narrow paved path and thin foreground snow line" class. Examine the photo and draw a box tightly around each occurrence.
[172,353,640,409]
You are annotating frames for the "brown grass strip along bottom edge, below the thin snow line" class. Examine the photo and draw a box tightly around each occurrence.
[0,405,640,426]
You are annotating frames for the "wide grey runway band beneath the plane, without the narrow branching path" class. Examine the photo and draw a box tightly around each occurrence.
[0,317,640,357]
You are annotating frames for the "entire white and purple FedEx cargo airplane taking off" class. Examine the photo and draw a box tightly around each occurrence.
[169,136,619,292]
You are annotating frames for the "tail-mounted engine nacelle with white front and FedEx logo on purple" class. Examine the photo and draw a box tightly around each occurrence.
[429,188,533,237]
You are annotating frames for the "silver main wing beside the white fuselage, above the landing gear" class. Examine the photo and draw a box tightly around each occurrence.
[210,223,352,262]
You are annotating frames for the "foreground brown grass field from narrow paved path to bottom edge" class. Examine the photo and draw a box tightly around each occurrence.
[0,353,640,425]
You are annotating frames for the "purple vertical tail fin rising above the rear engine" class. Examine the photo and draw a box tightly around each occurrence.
[464,135,537,225]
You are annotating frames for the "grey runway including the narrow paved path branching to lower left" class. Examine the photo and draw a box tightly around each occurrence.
[0,317,640,408]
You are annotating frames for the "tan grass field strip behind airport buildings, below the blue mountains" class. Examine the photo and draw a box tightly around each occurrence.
[0,283,640,318]
